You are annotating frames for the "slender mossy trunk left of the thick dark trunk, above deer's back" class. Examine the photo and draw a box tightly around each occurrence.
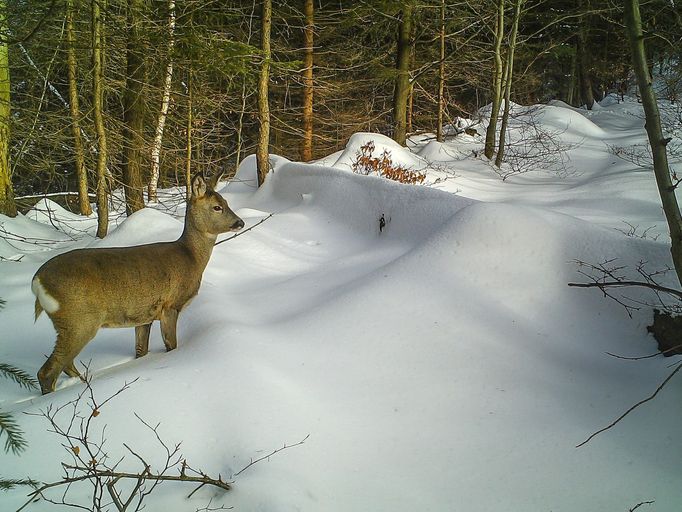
[92,0,109,238]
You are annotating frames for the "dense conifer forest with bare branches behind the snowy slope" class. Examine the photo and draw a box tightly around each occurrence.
[0,0,682,225]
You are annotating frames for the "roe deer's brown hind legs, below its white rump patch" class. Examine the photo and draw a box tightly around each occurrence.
[38,327,97,395]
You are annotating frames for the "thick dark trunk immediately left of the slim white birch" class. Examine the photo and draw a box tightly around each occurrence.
[122,0,145,215]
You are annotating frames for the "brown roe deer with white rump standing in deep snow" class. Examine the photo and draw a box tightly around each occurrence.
[31,175,244,394]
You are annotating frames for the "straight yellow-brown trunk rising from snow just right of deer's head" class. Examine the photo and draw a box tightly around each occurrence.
[256,0,272,187]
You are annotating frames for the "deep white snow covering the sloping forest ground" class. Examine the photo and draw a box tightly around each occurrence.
[0,95,682,512]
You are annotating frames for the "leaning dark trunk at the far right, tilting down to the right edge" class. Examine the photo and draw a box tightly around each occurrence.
[625,0,682,284]
